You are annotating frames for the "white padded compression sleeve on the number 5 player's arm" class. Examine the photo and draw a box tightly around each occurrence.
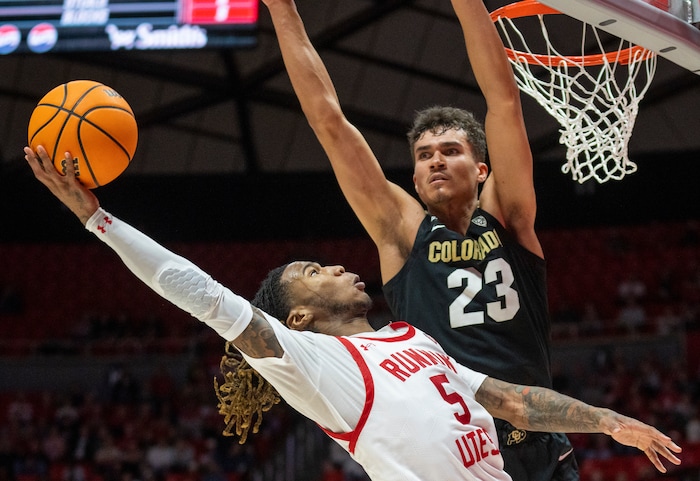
[85,208,253,341]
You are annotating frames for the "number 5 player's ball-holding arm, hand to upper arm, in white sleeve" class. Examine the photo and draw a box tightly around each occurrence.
[24,142,283,358]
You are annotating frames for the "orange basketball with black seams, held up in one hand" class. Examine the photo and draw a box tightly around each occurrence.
[28,80,138,189]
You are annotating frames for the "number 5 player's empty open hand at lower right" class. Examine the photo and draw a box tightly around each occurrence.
[601,414,682,473]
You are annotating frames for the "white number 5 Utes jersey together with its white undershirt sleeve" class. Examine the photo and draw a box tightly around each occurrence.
[245,316,510,481]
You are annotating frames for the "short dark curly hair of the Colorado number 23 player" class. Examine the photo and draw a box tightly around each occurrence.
[406,106,486,162]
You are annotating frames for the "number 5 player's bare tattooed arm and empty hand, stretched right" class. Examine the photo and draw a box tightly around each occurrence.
[476,377,681,473]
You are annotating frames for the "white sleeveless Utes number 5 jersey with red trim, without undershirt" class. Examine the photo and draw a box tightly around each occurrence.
[328,323,510,480]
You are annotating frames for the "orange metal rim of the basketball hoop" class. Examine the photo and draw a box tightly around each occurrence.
[491,0,647,66]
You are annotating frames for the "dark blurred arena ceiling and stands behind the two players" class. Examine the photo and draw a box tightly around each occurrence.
[0,0,700,481]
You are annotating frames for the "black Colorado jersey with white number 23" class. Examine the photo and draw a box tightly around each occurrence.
[383,209,552,388]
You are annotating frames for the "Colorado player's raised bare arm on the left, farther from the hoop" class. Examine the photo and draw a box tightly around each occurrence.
[263,0,424,278]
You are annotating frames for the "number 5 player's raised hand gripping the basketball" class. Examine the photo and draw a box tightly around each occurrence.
[24,146,100,224]
